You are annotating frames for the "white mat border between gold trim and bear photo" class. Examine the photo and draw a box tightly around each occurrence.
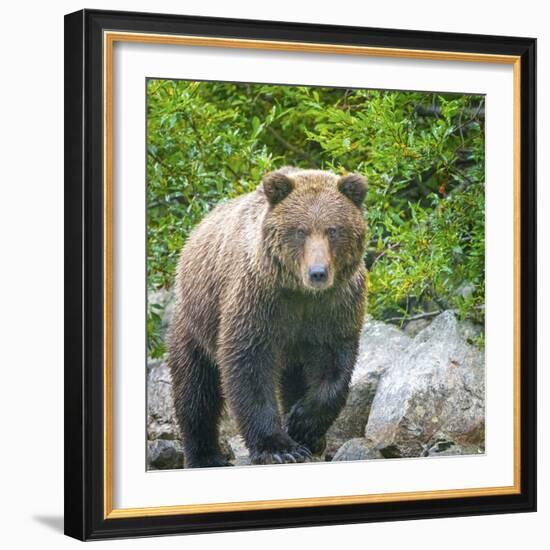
[113,43,514,508]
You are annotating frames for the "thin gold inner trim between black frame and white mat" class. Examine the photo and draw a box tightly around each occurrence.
[103,31,521,519]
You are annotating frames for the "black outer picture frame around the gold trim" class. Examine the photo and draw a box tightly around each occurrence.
[65,10,537,540]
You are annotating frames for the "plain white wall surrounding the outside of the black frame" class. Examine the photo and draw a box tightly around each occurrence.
[0,0,550,550]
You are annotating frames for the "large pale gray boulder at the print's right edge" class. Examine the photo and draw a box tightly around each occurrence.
[365,311,485,458]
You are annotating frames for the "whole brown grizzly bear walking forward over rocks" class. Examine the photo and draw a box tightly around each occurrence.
[168,167,367,468]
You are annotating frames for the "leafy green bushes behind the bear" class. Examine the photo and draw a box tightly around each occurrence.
[147,80,485,356]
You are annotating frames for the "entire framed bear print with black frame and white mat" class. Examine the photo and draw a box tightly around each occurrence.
[65,10,536,540]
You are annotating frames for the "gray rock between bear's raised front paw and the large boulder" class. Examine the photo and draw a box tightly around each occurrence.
[325,318,411,460]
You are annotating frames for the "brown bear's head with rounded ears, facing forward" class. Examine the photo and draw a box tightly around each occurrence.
[261,168,367,292]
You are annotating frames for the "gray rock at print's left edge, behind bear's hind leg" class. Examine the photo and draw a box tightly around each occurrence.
[147,359,179,439]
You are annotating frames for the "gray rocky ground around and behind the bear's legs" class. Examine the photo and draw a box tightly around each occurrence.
[147,298,485,469]
